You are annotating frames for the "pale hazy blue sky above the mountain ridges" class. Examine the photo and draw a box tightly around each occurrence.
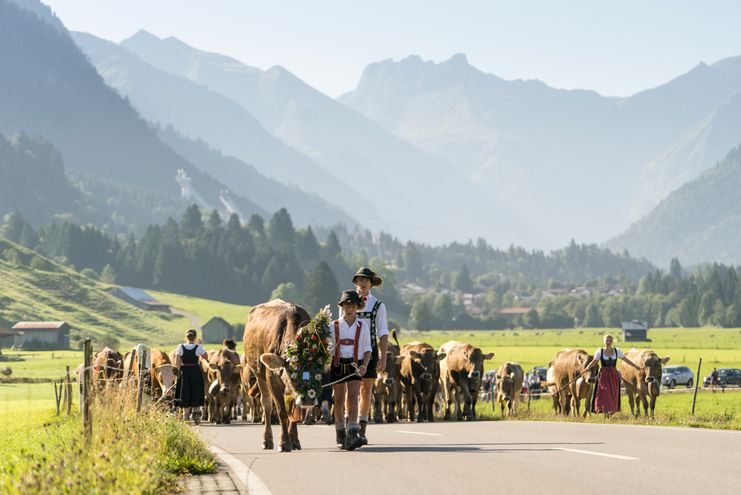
[45,0,741,96]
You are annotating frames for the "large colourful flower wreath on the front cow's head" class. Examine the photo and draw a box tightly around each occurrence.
[283,306,332,415]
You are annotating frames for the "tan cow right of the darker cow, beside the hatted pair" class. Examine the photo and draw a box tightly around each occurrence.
[439,340,494,421]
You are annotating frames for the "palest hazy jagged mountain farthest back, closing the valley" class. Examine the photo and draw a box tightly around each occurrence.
[339,54,741,243]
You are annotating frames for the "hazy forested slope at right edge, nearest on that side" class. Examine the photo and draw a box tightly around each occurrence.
[607,143,741,265]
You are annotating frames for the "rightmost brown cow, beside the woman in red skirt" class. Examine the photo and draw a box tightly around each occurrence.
[620,349,669,418]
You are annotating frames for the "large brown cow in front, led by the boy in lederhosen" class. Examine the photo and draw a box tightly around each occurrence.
[243,299,317,452]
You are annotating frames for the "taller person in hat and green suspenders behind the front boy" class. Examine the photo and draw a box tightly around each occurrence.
[352,267,389,444]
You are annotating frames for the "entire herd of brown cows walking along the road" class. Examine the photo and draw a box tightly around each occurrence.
[79,300,669,451]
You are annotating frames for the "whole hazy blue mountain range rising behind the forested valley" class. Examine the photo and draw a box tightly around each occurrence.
[0,0,741,268]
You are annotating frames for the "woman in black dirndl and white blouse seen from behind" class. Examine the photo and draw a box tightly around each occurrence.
[175,328,206,424]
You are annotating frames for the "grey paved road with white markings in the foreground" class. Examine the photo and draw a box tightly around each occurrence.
[199,421,741,495]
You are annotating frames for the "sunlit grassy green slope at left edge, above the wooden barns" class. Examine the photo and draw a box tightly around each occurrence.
[0,238,188,347]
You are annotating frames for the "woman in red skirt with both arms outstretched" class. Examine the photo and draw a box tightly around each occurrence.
[588,335,641,417]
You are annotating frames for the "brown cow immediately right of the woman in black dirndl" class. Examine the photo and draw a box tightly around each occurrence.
[206,349,242,424]
